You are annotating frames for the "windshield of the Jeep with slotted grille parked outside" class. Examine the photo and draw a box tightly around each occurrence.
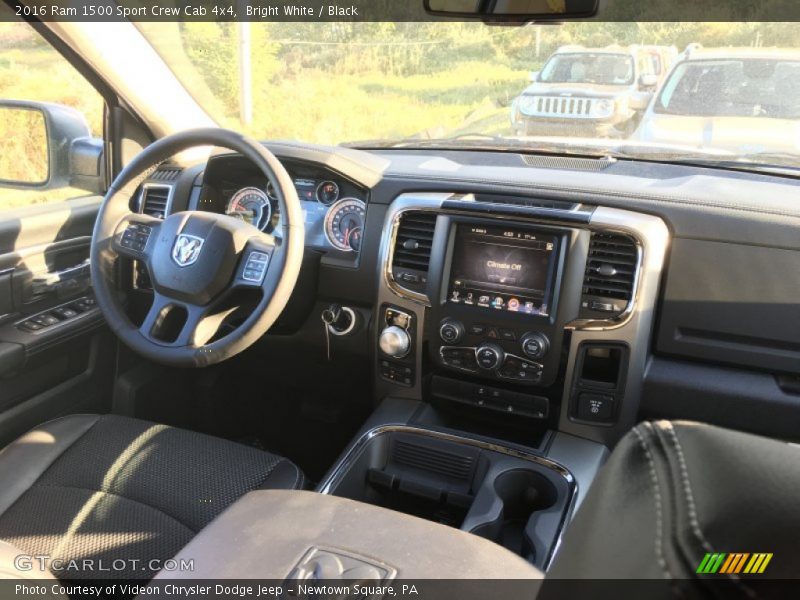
[539,54,633,85]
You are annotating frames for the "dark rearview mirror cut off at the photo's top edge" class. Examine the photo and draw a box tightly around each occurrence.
[425,0,598,21]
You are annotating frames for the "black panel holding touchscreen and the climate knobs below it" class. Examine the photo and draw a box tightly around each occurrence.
[428,216,571,386]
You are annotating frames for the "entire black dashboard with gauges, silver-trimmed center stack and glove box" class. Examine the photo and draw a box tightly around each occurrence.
[138,143,800,444]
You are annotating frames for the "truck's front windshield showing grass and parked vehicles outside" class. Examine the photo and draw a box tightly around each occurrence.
[136,22,800,167]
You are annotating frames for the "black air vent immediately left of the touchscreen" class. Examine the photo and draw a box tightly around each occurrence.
[392,211,436,293]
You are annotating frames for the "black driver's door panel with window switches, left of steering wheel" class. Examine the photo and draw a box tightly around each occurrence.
[0,197,116,445]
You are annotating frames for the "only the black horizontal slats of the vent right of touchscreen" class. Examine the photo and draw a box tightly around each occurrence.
[583,232,638,303]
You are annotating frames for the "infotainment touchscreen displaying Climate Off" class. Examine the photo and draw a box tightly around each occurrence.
[447,224,558,316]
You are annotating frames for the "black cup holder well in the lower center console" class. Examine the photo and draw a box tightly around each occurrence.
[472,469,558,562]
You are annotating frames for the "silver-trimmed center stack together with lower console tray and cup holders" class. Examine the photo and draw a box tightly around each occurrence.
[342,193,669,569]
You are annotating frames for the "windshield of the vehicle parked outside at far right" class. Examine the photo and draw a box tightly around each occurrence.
[658,59,800,119]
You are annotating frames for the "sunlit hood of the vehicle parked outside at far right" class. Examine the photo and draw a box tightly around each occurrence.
[634,114,800,154]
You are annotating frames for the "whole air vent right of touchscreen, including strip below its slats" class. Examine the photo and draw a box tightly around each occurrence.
[581,232,639,318]
